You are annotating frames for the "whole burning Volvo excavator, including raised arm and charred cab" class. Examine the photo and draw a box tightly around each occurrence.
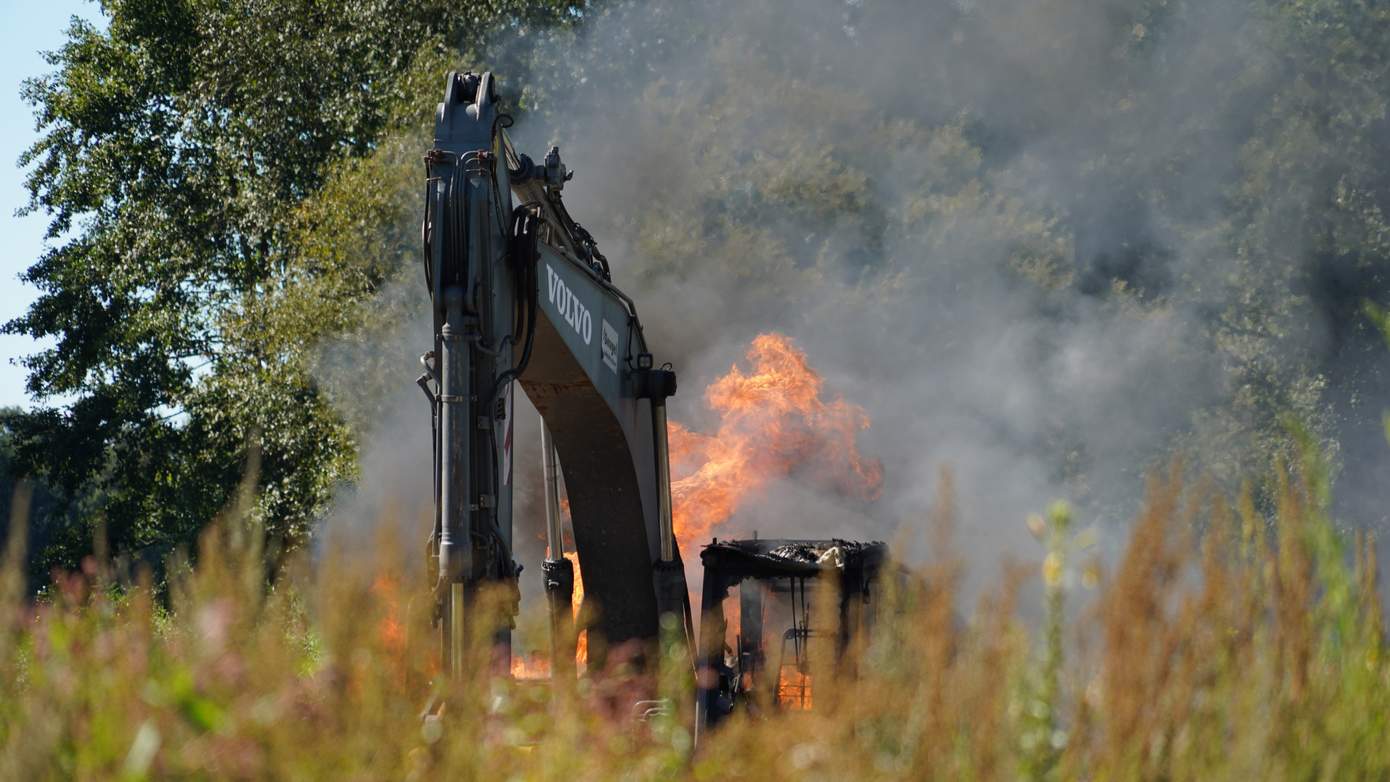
[417,72,885,729]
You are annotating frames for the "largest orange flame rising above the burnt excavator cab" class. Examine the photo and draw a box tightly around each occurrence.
[669,333,883,542]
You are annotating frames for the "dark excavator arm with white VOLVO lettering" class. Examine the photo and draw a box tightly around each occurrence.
[420,72,691,671]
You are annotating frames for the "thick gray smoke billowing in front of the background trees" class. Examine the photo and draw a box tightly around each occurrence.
[322,0,1383,622]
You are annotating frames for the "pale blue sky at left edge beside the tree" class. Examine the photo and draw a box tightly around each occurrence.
[0,0,101,407]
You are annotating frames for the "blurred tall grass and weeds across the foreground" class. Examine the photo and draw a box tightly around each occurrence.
[0,460,1390,782]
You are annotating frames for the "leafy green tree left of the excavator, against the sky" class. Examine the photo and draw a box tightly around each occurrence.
[4,0,577,575]
